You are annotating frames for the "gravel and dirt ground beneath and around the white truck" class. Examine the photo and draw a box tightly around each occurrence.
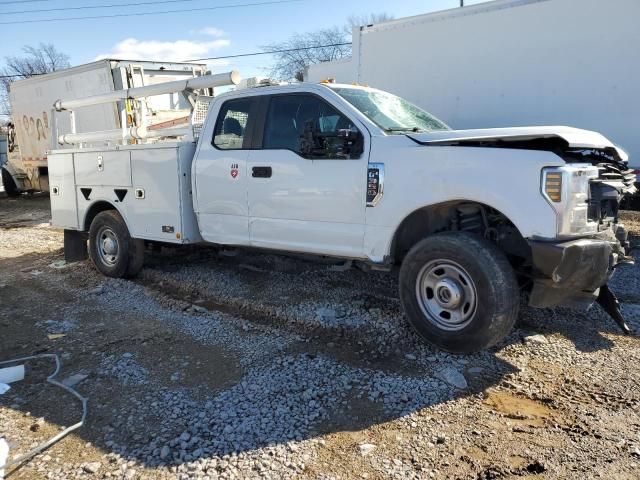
[0,196,640,479]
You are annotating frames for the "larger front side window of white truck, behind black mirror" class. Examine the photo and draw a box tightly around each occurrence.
[262,94,362,159]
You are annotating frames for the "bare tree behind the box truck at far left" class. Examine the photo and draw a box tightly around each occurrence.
[0,43,71,113]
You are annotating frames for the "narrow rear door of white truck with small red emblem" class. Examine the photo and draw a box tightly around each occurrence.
[193,98,257,245]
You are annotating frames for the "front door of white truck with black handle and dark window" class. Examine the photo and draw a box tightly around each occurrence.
[247,93,369,258]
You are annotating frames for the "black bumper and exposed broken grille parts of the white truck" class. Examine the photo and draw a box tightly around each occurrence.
[529,146,636,334]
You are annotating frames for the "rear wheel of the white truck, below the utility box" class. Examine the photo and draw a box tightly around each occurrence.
[89,210,144,278]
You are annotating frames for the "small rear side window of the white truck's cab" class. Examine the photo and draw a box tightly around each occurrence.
[213,98,253,150]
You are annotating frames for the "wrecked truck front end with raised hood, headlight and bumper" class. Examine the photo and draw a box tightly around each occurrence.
[407,127,637,333]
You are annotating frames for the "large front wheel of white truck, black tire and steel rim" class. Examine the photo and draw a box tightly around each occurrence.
[400,232,520,353]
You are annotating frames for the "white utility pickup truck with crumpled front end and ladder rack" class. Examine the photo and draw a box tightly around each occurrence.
[49,74,635,352]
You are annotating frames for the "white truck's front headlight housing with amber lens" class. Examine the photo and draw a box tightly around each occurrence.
[542,164,598,236]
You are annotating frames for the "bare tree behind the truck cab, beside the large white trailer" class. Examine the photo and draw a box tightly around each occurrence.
[262,13,392,81]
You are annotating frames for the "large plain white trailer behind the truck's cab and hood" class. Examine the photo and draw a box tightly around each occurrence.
[305,0,640,180]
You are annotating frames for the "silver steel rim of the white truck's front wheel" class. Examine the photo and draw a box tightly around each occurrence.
[416,260,478,331]
